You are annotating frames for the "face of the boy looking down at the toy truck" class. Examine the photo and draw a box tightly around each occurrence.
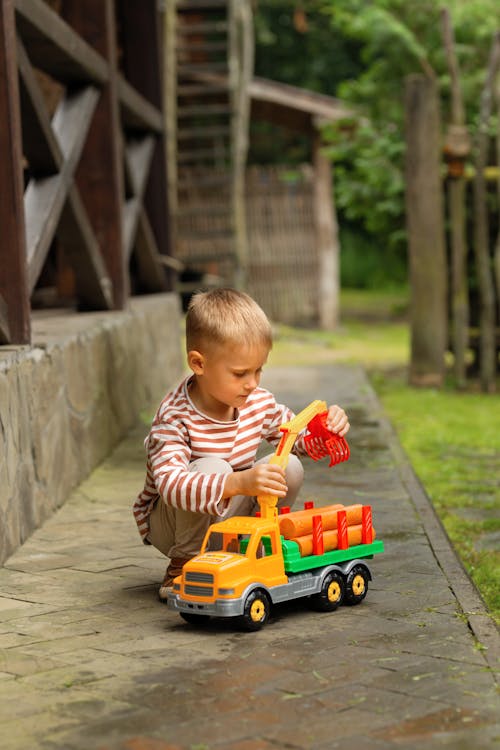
[188,344,269,419]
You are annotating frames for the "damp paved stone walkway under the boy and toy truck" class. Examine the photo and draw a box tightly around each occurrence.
[0,366,500,750]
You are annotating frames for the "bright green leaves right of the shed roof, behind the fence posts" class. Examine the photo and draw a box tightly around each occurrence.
[323,0,500,282]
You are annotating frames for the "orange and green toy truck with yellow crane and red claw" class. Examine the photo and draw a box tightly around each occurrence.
[168,401,384,630]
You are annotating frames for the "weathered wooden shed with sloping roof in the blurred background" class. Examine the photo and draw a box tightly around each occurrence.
[247,78,353,330]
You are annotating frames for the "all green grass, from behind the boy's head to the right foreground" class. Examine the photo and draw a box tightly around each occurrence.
[269,292,500,621]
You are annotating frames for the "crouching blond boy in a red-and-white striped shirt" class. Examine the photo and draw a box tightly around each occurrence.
[134,289,349,601]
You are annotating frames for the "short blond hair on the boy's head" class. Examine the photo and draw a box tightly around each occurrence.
[186,289,272,352]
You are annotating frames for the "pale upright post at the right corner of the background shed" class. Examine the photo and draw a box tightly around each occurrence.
[313,131,340,331]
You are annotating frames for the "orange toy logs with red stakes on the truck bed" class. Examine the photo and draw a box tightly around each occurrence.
[278,502,375,557]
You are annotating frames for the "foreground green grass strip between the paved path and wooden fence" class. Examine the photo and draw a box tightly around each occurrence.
[372,373,500,621]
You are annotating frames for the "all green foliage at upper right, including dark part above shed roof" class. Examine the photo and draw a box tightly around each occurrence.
[251,0,500,285]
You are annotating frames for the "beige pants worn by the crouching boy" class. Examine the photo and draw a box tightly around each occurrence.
[148,454,304,558]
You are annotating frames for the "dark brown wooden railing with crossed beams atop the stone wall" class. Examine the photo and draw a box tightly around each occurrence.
[0,0,173,344]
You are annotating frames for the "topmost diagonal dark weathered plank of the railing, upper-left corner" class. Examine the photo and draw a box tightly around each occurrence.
[15,0,108,84]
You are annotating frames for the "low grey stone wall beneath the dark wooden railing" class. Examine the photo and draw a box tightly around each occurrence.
[0,294,184,563]
